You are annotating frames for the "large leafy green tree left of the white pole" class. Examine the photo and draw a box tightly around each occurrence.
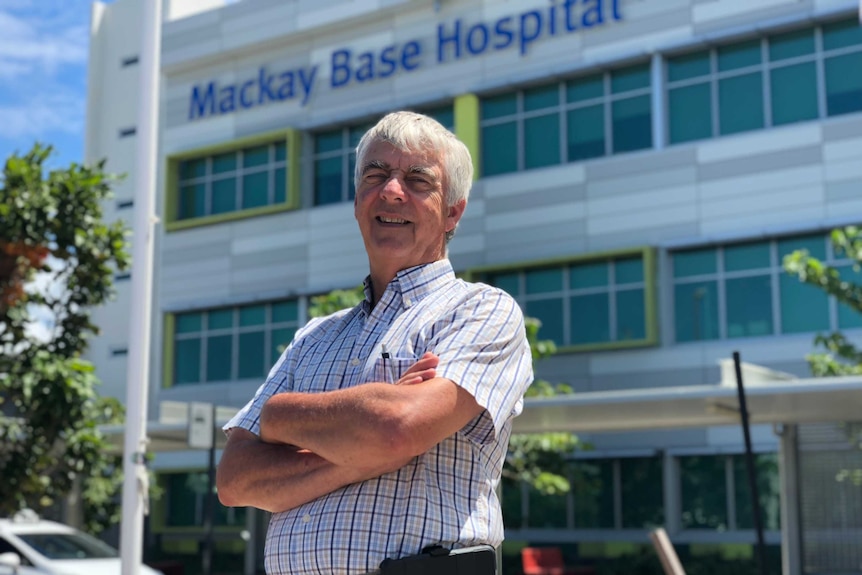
[0,144,129,531]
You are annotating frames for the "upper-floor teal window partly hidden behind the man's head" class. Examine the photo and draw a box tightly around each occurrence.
[313,104,455,206]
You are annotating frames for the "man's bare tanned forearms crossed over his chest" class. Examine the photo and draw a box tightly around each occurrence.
[216,353,482,512]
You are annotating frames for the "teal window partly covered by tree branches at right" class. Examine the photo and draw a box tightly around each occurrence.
[673,233,862,342]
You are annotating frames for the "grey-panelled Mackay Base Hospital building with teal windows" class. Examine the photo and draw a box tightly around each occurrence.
[86,0,862,573]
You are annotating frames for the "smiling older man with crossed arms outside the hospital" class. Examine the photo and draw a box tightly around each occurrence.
[218,112,532,575]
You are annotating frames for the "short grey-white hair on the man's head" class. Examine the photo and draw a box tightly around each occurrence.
[353,111,473,241]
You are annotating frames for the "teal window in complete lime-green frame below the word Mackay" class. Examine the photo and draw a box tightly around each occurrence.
[176,140,287,220]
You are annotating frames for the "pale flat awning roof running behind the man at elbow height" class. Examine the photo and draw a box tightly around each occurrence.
[104,360,862,452]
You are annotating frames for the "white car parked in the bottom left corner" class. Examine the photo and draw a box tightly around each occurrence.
[0,512,161,575]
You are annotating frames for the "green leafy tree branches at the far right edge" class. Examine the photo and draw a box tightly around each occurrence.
[784,226,862,485]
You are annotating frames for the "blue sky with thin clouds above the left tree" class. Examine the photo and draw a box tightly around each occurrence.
[0,0,97,171]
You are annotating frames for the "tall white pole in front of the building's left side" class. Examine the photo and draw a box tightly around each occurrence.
[120,0,162,575]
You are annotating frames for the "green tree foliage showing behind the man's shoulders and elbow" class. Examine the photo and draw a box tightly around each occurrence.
[309,286,580,495]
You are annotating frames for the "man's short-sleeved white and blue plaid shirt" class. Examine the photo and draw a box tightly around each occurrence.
[225,260,533,575]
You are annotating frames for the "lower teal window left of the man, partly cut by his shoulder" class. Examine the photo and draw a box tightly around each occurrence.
[173,300,299,385]
